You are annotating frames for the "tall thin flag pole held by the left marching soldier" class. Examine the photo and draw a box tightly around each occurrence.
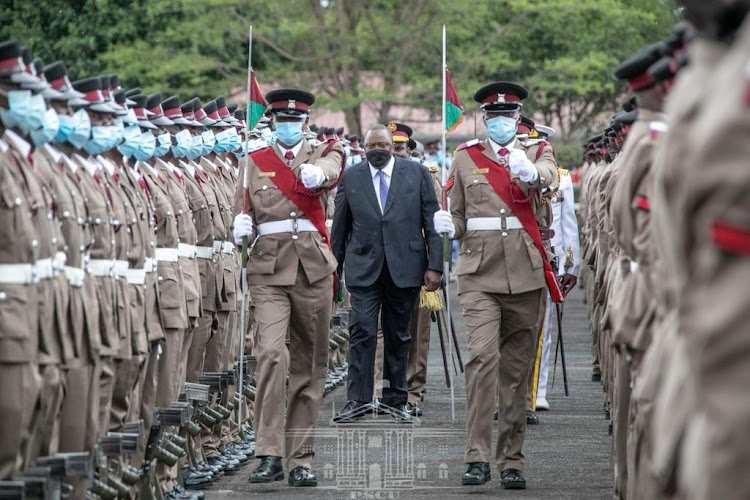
[237,24,253,432]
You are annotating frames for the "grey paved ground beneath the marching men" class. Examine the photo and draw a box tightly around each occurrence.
[206,290,611,500]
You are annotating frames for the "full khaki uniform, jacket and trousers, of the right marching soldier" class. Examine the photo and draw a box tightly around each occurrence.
[450,140,557,470]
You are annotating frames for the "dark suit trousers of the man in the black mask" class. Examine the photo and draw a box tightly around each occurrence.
[347,263,420,406]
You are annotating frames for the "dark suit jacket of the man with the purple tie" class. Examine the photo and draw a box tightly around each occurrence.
[331,157,443,288]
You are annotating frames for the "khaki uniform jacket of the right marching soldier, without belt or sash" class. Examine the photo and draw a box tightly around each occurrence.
[449,140,558,294]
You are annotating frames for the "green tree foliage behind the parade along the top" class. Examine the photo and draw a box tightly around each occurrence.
[0,0,675,142]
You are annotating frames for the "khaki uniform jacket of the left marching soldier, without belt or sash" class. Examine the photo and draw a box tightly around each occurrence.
[234,139,344,286]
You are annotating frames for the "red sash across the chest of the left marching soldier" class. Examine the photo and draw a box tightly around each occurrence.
[250,147,331,248]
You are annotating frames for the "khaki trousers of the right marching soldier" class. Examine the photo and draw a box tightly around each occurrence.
[460,288,545,471]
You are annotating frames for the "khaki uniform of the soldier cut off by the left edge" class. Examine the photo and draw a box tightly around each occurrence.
[0,138,41,479]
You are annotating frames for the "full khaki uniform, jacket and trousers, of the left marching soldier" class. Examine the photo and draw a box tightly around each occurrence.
[234,139,344,470]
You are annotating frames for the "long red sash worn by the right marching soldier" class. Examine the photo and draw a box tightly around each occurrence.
[466,144,563,303]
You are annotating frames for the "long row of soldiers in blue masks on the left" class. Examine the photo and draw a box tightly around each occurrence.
[0,41,360,499]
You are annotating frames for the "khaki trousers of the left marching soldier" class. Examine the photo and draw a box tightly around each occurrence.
[248,265,330,471]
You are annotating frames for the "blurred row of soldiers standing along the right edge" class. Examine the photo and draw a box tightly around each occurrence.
[581,1,750,499]
